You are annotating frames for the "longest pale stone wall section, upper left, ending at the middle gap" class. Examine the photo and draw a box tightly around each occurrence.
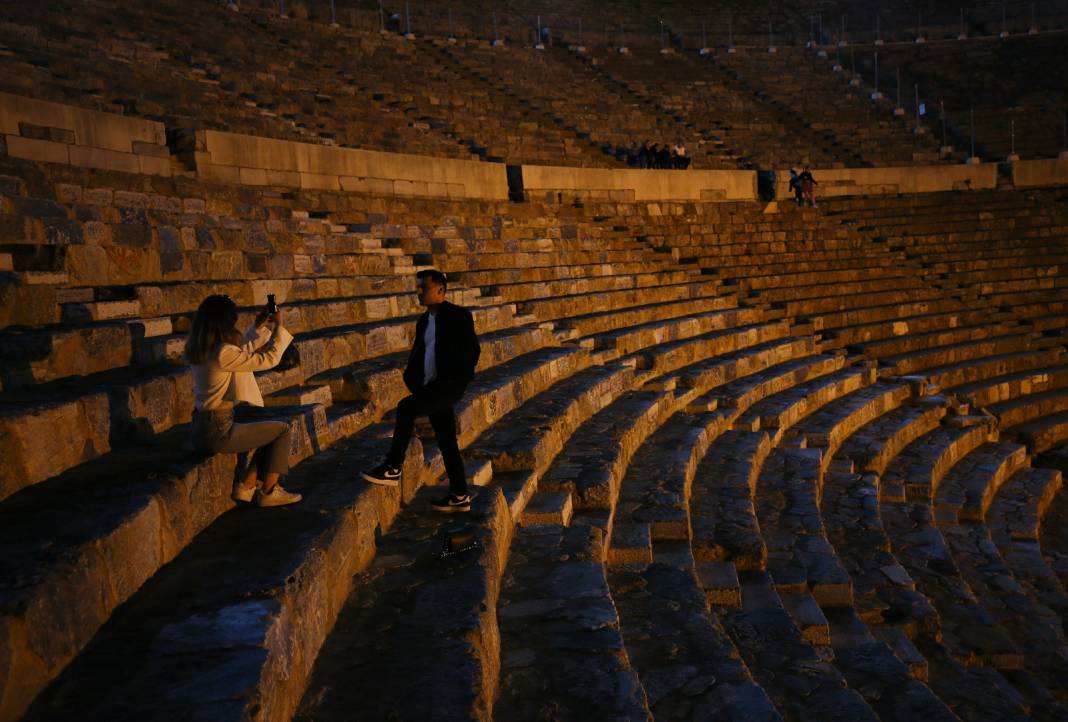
[197,130,508,200]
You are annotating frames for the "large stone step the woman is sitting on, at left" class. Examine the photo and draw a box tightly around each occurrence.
[0,397,354,706]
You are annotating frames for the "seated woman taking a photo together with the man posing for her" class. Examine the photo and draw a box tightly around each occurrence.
[186,269,480,513]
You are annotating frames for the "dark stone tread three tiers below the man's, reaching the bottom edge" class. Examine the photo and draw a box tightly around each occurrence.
[722,571,878,720]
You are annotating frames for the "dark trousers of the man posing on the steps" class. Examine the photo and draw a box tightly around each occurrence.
[387,381,468,495]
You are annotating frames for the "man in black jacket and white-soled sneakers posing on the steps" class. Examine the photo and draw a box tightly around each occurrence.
[362,269,480,513]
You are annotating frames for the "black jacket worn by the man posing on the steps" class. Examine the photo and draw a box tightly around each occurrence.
[404,301,480,393]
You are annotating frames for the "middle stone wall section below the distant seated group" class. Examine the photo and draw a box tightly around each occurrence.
[523,166,756,201]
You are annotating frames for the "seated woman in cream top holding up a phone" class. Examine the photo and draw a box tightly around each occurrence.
[186,296,301,506]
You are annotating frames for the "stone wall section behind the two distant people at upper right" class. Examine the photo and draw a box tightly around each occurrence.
[775,164,998,199]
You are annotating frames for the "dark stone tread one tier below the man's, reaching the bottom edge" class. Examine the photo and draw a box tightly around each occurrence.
[493,524,650,722]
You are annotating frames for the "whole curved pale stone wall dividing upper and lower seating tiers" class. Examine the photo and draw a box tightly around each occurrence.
[6,93,1068,202]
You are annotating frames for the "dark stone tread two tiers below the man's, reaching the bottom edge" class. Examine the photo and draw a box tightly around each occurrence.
[608,558,782,721]
